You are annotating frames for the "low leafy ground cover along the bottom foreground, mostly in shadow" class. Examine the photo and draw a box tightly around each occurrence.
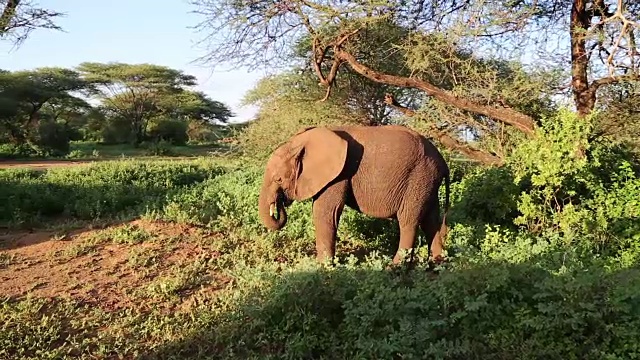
[5,257,640,359]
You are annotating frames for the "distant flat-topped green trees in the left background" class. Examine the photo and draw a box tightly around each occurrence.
[0,63,234,151]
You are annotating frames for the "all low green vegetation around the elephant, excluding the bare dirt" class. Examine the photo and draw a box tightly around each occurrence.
[0,112,640,359]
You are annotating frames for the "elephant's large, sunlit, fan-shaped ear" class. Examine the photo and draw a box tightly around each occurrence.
[291,127,347,200]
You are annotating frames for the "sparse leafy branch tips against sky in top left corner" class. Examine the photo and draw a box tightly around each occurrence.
[0,0,63,44]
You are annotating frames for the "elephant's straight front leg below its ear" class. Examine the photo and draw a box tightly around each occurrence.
[313,180,347,262]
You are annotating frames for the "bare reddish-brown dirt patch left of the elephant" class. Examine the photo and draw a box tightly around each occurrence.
[0,220,226,311]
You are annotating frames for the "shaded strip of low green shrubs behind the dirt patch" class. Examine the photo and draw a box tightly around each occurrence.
[0,161,224,223]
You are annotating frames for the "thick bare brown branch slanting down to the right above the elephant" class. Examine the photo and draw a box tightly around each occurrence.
[335,48,535,136]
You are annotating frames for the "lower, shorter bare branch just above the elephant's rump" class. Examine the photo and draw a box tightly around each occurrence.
[384,94,504,165]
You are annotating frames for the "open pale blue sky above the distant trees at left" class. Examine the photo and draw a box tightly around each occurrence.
[0,0,263,122]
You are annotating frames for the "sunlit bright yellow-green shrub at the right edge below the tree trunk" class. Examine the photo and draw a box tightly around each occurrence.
[510,111,640,252]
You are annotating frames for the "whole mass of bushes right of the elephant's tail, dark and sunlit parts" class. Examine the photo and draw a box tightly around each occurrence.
[450,110,640,264]
